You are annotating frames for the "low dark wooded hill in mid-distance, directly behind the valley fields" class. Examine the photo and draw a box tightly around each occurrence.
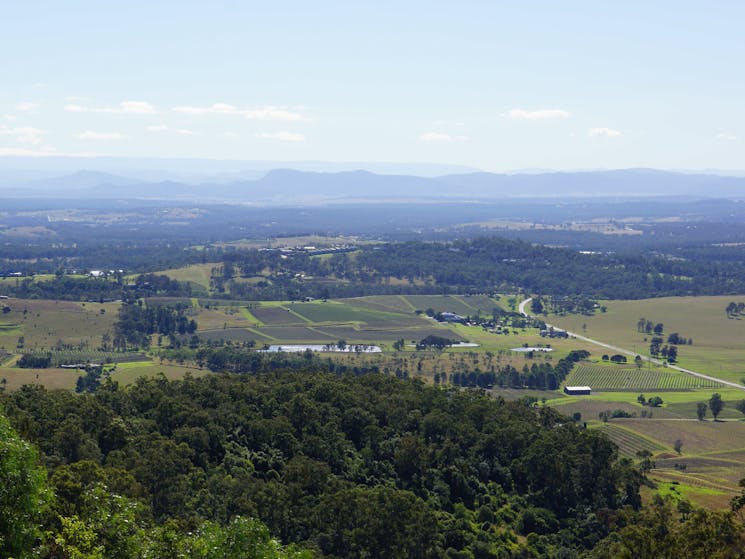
[218,237,745,304]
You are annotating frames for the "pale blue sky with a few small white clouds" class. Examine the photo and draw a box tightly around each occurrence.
[0,0,745,171]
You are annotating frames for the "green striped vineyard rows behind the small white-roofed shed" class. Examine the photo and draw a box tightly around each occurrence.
[566,363,720,397]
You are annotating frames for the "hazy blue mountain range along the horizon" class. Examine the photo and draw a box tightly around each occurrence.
[0,164,745,204]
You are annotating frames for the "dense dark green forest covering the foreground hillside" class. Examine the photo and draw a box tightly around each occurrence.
[0,371,742,558]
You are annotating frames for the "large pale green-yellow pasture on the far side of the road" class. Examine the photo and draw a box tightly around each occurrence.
[547,295,745,382]
